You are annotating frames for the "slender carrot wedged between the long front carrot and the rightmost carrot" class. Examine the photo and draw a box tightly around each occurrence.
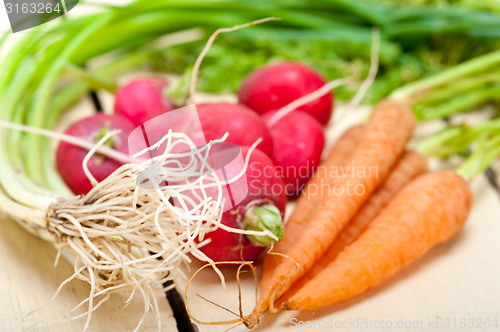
[276,151,427,307]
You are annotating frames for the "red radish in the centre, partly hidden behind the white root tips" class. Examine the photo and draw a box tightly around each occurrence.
[196,103,273,156]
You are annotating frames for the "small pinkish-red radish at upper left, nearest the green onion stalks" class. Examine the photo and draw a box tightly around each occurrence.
[115,77,174,126]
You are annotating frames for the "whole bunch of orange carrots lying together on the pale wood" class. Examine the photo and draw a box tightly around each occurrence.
[247,99,472,328]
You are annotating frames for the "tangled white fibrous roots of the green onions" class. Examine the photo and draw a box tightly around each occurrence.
[43,131,273,327]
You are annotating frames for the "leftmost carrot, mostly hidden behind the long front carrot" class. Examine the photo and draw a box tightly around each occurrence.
[260,125,365,298]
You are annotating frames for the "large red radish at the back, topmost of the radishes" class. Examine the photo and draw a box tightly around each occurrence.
[238,62,333,125]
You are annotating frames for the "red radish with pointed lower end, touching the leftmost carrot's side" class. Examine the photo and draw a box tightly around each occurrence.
[264,111,325,198]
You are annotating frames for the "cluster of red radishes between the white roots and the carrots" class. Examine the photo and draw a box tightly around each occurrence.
[189,62,333,261]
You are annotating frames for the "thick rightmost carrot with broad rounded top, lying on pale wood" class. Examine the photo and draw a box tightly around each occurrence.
[283,171,472,310]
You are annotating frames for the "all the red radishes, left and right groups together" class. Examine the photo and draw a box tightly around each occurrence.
[57,62,333,261]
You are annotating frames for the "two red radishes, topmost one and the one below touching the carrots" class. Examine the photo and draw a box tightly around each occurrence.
[238,62,333,198]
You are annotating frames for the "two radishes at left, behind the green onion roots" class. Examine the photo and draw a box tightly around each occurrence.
[56,77,174,195]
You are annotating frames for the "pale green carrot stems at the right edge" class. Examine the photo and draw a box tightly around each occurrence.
[391,51,500,180]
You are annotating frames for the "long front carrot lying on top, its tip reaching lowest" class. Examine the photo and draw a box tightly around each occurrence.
[248,100,415,327]
